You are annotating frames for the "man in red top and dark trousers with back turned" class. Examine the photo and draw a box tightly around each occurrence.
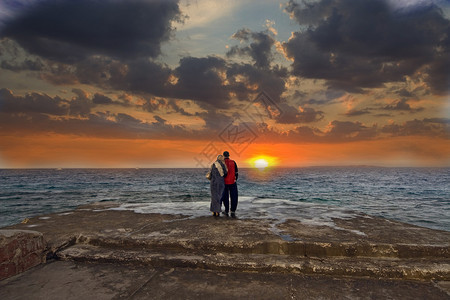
[222,151,238,218]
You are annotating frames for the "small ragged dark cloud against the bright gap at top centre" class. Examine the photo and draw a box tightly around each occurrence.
[227,28,275,68]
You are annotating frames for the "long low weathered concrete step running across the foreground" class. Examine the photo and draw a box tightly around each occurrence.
[58,245,450,280]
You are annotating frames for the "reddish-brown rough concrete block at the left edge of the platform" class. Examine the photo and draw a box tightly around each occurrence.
[0,230,46,280]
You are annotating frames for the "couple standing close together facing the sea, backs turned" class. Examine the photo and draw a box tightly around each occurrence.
[206,151,238,218]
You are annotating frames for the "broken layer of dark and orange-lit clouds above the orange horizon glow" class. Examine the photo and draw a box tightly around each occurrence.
[0,0,450,166]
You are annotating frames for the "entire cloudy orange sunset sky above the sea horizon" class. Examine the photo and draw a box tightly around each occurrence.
[0,0,450,168]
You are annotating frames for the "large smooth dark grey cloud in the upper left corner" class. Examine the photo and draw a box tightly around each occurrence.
[1,0,180,63]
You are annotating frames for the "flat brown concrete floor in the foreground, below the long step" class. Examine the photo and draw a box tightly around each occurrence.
[0,261,450,300]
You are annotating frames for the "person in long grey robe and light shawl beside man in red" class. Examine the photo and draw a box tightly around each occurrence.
[209,155,228,217]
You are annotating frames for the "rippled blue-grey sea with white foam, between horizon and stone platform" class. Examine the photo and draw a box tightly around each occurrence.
[0,167,450,231]
